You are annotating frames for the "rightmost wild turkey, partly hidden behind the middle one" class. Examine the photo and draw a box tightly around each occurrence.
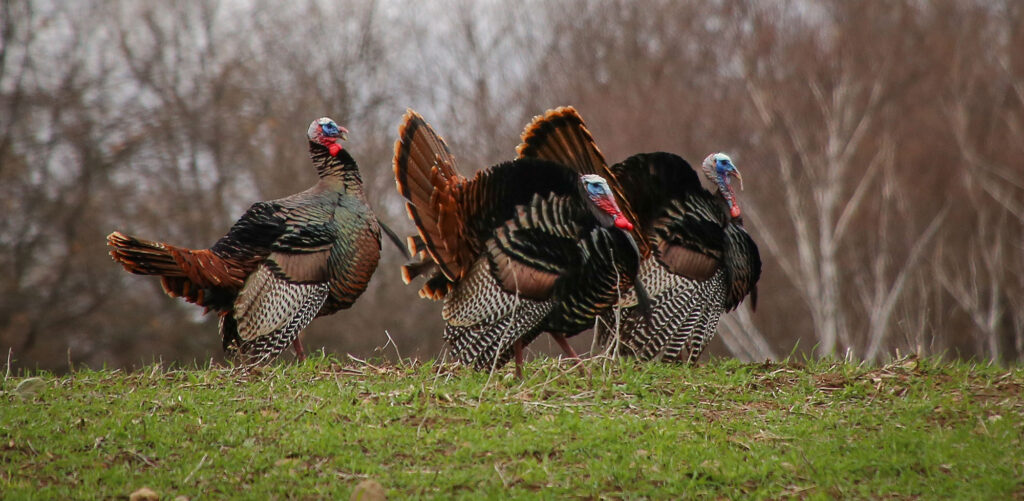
[517,108,761,362]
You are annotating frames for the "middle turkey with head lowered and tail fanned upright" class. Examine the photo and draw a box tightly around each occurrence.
[394,110,639,371]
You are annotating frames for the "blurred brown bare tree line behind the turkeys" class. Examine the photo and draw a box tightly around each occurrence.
[0,0,1024,370]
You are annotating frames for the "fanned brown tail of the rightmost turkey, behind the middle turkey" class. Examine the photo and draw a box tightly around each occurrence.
[515,107,650,255]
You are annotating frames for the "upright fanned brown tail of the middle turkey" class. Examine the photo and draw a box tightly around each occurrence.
[394,110,470,288]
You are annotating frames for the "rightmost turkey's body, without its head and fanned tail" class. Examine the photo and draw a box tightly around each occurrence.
[601,153,761,363]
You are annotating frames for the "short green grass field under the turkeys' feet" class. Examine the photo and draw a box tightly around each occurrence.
[0,359,1024,500]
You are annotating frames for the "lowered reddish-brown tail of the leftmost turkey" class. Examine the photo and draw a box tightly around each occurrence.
[106,232,247,305]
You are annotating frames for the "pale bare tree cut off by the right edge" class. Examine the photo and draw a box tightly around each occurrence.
[933,2,1024,362]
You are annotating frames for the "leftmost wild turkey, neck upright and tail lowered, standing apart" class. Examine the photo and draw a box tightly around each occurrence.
[106,117,381,362]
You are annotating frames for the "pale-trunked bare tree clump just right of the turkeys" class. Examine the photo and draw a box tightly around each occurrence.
[729,2,966,359]
